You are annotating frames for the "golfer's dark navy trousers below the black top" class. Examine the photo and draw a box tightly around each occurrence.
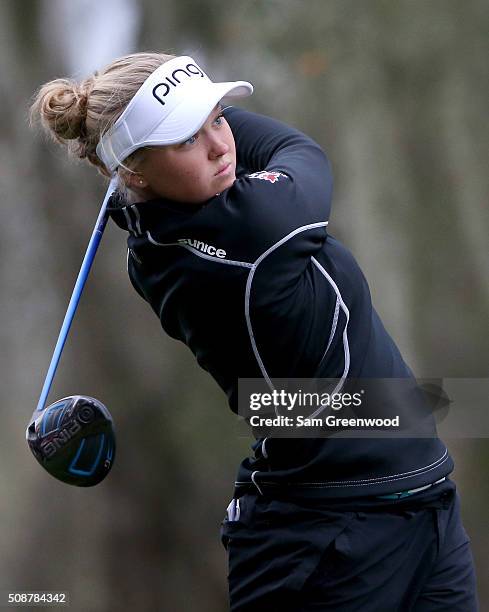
[221,483,478,612]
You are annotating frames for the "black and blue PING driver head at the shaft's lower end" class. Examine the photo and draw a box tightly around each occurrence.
[26,395,115,487]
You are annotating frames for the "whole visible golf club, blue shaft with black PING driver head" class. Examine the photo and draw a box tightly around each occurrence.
[26,176,117,487]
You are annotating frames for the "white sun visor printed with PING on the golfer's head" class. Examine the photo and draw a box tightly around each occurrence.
[97,56,253,172]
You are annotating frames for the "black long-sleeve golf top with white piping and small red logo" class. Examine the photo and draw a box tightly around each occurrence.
[109,108,453,499]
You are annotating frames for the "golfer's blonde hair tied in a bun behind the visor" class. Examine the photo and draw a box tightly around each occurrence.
[30,52,175,176]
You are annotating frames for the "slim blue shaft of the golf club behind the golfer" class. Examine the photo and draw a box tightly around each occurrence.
[36,176,117,411]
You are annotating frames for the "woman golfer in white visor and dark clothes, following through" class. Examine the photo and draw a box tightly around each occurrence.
[32,53,477,612]
